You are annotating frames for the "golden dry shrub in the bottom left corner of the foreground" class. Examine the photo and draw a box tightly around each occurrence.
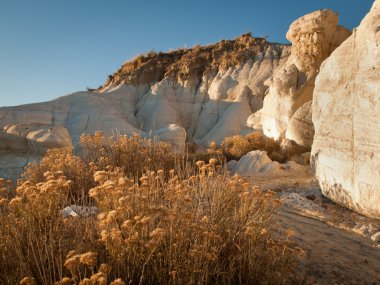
[0,172,99,284]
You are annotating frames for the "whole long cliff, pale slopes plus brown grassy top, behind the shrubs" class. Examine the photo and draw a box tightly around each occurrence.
[0,35,290,180]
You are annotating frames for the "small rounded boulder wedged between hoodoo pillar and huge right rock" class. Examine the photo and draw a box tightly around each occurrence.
[286,101,314,148]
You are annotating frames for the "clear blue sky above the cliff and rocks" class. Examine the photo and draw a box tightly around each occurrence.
[0,0,373,106]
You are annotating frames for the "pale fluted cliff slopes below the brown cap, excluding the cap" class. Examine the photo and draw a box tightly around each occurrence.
[0,37,289,149]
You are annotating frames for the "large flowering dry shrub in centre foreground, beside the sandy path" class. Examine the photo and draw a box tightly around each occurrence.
[85,165,296,284]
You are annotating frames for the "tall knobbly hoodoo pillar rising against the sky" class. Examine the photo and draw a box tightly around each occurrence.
[261,10,351,139]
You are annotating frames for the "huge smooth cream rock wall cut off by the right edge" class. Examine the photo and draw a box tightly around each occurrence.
[311,0,380,219]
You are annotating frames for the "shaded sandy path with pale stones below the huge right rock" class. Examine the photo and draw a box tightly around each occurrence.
[246,171,380,284]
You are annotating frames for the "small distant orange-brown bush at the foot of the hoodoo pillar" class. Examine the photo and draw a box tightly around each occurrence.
[217,132,290,163]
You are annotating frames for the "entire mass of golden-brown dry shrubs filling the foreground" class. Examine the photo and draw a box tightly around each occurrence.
[0,133,299,285]
